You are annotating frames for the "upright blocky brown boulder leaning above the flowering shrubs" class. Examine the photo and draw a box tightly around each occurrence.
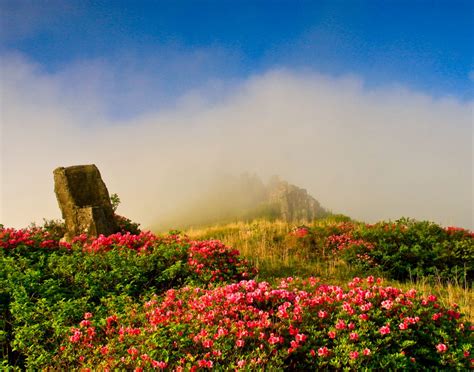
[53,164,119,240]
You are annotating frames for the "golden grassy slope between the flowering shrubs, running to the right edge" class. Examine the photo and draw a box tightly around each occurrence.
[184,216,474,321]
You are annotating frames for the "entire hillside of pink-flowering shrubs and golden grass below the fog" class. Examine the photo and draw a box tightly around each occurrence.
[0,216,474,372]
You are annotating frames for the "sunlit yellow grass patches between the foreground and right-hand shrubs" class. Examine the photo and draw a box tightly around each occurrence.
[185,219,474,321]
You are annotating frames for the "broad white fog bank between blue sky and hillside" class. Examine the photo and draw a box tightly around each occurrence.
[0,58,473,228]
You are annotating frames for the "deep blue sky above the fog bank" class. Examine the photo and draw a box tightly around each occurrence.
[0,0,474,110]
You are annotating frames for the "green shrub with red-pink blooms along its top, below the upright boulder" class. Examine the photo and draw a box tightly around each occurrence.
[0,227,255,369]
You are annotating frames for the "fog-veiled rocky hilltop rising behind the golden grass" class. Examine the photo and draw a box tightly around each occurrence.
[155,173,331,230]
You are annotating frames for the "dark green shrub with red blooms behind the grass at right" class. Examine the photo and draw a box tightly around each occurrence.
[313,219,474,282]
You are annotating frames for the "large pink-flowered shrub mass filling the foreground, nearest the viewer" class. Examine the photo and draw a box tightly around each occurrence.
[55,277,472,371]
